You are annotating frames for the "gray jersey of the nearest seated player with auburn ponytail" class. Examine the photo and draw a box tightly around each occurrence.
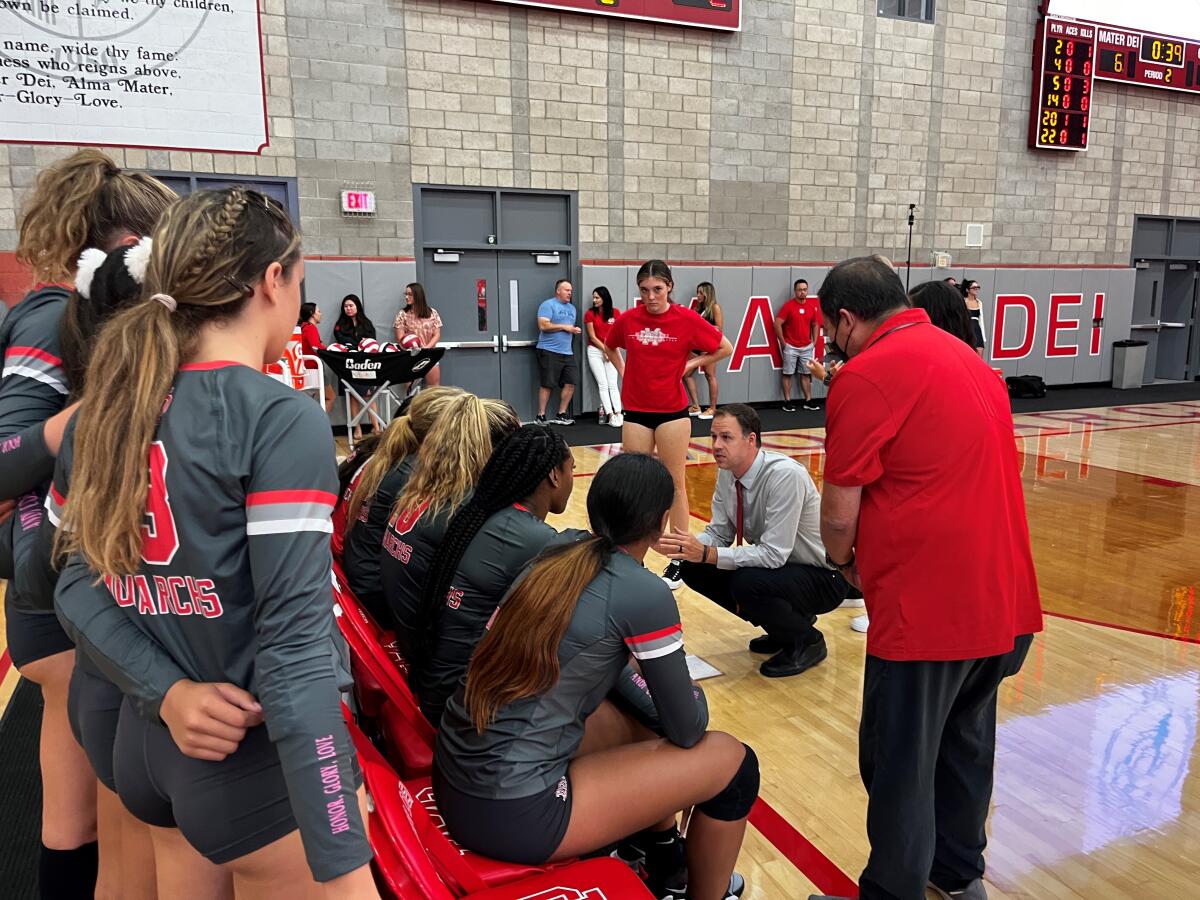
[436,551,708,799]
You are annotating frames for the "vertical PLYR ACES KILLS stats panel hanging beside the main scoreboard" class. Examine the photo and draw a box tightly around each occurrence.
[1030,18,1096,150]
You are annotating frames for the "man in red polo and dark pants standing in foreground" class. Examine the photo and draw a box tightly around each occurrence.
[821,257,1042,900]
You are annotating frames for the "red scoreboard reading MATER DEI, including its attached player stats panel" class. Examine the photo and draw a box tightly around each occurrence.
[1030,0,1200,150]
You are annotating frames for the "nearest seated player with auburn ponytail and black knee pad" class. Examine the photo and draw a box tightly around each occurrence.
[433,454,758,900]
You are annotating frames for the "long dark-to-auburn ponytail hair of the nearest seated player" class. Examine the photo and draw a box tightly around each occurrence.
[466,454,674,734]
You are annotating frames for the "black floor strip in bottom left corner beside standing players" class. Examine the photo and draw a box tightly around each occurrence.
[0,678,42,900]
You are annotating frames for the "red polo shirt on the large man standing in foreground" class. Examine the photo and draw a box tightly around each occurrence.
[824,310,1042,660]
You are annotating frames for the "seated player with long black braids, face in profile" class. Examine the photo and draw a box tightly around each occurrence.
[397,425,587,725]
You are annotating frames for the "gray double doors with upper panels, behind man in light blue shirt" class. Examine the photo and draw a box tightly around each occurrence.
[418,187,582,421]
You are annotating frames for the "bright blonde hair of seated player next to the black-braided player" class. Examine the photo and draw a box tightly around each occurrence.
[392,394,521,515]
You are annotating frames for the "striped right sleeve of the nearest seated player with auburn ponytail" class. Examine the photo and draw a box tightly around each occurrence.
[617,583,708,748]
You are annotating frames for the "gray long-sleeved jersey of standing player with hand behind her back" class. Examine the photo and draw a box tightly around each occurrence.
[48,362,371,881]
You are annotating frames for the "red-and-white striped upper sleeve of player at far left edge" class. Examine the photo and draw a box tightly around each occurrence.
[0,301,67,438]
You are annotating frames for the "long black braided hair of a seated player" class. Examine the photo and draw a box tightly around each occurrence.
[416,425,571,655]
